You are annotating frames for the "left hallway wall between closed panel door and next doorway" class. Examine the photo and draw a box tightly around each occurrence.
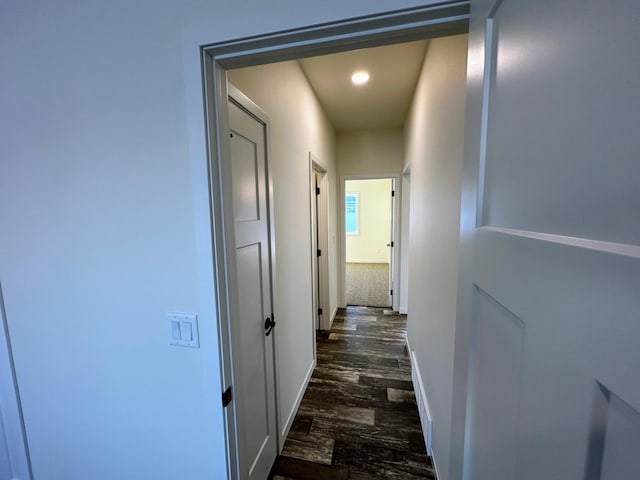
[228,61,337,438]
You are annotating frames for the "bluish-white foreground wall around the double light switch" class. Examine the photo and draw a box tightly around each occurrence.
[0,0,450,480]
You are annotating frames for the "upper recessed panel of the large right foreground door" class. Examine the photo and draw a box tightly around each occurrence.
[483,0,640,245]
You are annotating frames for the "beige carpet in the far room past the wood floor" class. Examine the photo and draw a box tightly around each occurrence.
[346,263,391,307]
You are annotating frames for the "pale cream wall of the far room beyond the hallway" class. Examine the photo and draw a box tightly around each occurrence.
[345,178,392,263]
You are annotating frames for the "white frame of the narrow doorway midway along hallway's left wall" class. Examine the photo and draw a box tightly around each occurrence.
[309,156,333,332]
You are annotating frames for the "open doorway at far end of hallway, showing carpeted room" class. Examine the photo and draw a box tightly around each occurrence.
[344,178,394,307]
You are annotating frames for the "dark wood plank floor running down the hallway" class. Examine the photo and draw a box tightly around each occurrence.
[271,307,435,480]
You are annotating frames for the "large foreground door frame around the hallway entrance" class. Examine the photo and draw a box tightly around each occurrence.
[200,0,470,479]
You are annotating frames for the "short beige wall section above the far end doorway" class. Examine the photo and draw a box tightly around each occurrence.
[336,128,403,177]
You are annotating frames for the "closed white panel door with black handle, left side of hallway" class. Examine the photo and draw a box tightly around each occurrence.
[229,95,278,480]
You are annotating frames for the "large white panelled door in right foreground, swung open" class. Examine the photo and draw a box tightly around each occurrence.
[452,0,640,480]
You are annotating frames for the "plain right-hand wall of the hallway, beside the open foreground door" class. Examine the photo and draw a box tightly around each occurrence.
[405,35,467,480]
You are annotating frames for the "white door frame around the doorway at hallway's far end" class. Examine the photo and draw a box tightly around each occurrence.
[338,173,402,311]
